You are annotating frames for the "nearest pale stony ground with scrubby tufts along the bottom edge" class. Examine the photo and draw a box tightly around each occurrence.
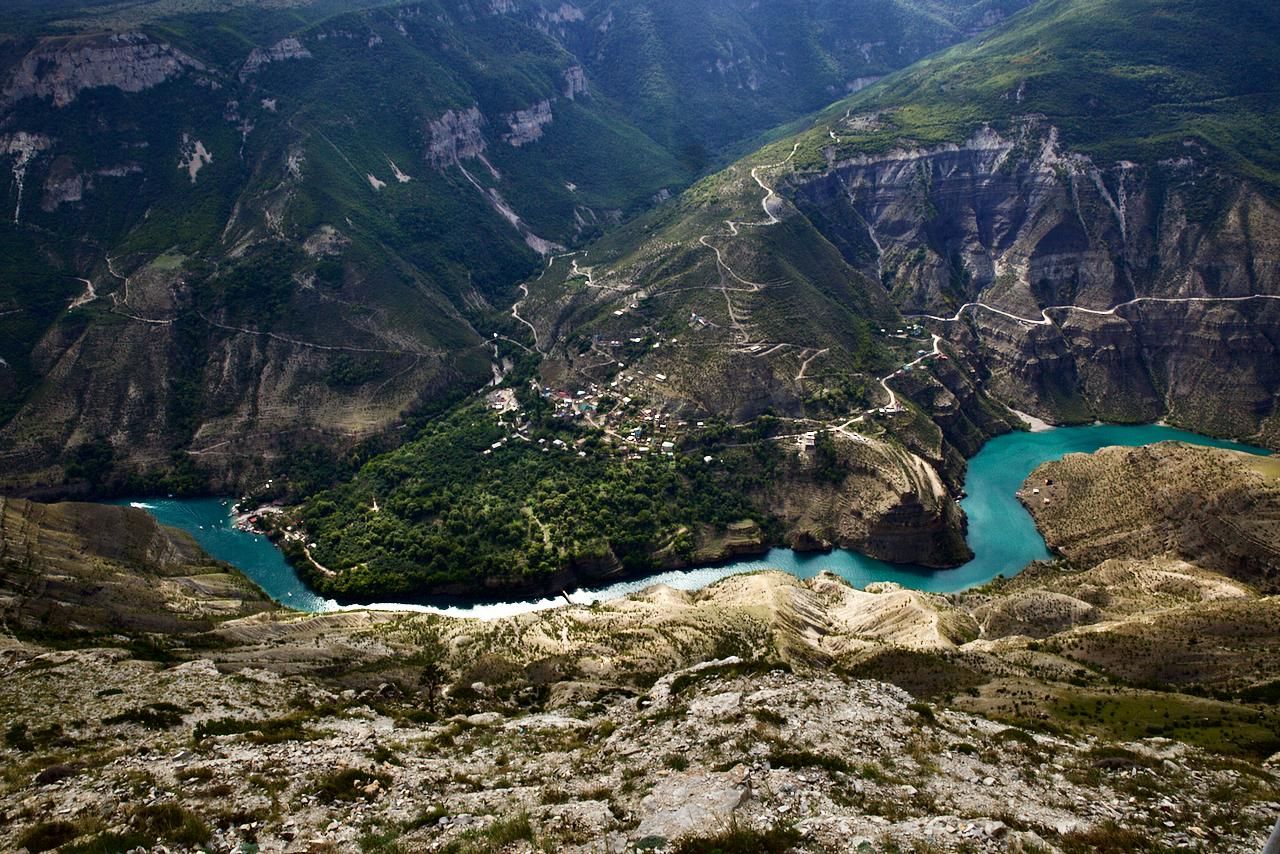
[4,650,1276,851]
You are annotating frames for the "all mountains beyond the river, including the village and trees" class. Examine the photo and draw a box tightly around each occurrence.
[0,0,1280,594]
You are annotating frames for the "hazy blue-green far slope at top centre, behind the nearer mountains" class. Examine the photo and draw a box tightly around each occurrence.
[566,0,1027,164]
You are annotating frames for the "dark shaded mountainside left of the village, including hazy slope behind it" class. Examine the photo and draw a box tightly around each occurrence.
[0,0,1021,489]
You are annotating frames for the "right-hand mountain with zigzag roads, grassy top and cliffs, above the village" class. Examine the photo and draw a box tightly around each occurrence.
[522,0,1280,453]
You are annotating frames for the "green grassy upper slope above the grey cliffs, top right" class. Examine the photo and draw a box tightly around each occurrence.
[810,0,1280,187]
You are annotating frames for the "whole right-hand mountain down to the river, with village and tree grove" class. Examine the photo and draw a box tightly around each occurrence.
[282,0,1280,594]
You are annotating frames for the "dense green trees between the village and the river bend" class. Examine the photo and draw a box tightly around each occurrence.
[296,403,769,595]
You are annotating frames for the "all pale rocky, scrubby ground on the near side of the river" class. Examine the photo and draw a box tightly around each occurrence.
[0,446,1280,853]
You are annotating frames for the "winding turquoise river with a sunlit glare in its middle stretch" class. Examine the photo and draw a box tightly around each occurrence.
[118,424,1268,617]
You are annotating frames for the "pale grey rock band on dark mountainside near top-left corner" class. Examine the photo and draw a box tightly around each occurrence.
[0,33,204,109]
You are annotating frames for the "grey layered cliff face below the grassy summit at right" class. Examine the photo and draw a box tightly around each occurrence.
[790,123,1280,440]
